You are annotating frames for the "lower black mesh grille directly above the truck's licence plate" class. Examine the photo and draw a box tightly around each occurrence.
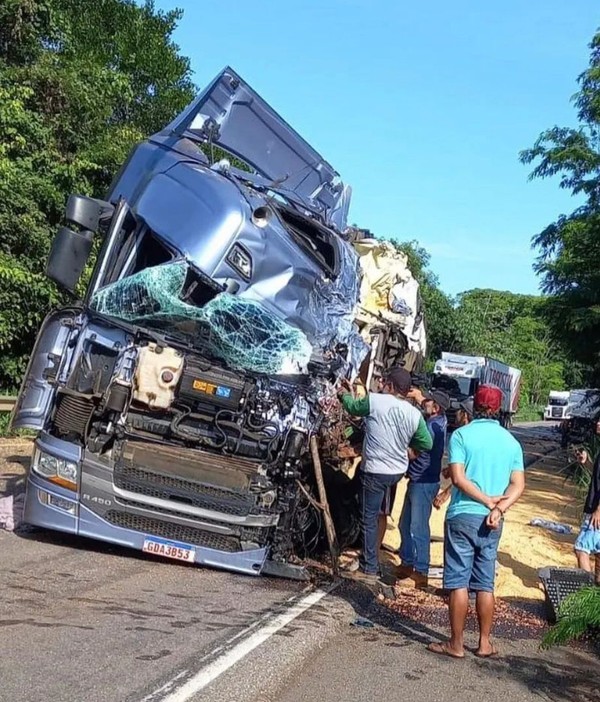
[104,509,241,553]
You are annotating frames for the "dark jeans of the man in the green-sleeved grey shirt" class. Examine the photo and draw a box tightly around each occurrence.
[359,472,402,575]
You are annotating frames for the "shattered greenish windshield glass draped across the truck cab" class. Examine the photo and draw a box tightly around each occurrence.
[91,260,312,374]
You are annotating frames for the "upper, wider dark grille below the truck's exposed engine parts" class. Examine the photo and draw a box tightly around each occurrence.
[113,463,254,517]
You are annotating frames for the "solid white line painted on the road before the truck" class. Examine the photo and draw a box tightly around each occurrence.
[145,586,334,702]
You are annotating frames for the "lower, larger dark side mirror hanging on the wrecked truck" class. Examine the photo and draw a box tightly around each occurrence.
[46,227,94,292]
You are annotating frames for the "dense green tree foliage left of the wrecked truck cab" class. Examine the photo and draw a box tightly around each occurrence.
[0,0,194,390]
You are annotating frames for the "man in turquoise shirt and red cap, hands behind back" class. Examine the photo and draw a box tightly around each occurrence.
[429,385,525,658]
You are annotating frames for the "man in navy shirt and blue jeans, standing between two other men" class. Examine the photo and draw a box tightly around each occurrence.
[398,391,450,588]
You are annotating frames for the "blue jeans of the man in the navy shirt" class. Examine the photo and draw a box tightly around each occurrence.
[400,482,440,575]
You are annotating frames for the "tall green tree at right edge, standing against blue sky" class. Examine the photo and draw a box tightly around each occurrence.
[521,27,600,382]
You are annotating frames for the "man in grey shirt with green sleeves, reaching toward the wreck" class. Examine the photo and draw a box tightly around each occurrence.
[341,366,432,581]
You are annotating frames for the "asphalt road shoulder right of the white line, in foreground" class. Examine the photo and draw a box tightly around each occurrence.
[198,585,600,702]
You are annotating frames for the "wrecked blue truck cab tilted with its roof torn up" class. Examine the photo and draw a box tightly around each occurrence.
[12,68,422,577]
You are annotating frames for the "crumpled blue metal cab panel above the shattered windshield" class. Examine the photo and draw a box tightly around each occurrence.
[113,155,367,368]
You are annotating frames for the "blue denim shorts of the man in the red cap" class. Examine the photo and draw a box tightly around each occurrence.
[444,514,502,592]
